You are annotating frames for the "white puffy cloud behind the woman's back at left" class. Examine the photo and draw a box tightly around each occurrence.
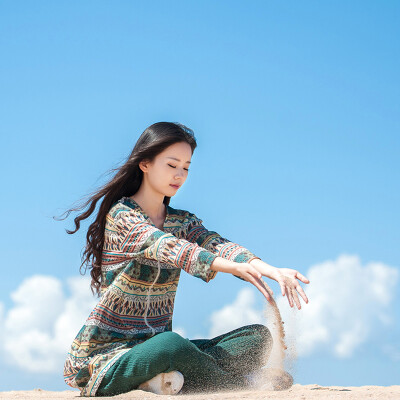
[0,275,97,373]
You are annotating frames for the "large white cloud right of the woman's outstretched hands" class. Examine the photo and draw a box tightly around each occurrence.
[277,254,399,358]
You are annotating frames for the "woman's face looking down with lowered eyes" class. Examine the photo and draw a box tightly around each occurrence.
[139,142,192,197]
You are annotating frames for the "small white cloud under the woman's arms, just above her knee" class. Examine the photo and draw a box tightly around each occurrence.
[208,287,263,338]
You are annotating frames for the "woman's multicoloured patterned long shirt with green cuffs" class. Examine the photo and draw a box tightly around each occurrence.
[64,197,259,396]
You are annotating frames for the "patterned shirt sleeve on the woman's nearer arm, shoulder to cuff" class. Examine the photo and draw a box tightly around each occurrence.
[115,211,217,282]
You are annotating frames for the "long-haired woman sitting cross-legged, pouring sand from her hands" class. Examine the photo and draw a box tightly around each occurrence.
[59,122,309,396]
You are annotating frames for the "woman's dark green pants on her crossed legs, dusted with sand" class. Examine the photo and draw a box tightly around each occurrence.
[96,324,272,396]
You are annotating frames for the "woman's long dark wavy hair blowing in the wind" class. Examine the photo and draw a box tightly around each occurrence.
[53,122,197,296]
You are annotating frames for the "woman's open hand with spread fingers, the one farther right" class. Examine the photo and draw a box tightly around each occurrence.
[250,259,310,310]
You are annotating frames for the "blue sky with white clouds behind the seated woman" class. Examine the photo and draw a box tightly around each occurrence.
[0,0,400,391]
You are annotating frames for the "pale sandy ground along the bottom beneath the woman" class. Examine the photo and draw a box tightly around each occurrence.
[0,384,400,400]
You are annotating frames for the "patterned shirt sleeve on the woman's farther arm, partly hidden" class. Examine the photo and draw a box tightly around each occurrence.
[186,213,260,281]
